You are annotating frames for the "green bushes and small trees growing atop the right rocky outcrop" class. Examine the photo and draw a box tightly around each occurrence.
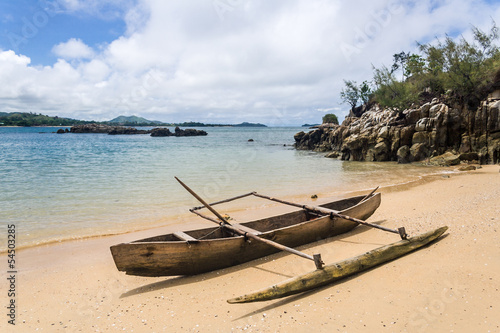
[340,22,500,112]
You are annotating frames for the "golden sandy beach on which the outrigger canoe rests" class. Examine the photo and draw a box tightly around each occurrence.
[0,165,500,332]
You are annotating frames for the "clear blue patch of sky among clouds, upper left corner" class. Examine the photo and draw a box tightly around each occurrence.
[0,0,126,65]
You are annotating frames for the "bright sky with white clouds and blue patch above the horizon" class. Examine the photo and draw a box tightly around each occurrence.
[0,0,500,126]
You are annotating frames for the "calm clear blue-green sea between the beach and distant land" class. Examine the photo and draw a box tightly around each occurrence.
[0,127,446,251]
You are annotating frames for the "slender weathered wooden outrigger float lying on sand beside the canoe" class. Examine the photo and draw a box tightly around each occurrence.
[227,226,448,304]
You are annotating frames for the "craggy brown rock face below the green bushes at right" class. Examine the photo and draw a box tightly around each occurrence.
[294,99,500,163]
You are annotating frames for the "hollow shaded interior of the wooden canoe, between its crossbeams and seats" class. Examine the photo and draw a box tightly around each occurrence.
[132,196,364,243]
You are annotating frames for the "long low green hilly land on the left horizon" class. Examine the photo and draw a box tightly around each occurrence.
[0,112,267,127]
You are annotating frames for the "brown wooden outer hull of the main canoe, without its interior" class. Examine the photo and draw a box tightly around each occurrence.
[111,193,381,276]
